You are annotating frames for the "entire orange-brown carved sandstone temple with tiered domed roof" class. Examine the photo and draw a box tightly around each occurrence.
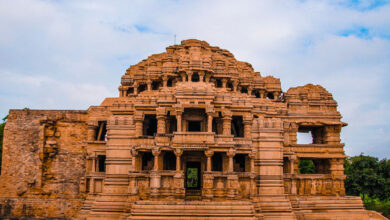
[0,40,385,220]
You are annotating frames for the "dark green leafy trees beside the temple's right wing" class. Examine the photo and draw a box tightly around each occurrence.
[344,154,390,216]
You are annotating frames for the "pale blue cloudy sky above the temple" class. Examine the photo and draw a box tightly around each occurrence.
[0,0,390,158]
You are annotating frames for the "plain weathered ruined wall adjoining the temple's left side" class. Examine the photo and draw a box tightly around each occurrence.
[0,109,87,218]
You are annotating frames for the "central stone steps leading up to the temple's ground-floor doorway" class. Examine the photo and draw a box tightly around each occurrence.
[127,201,257,220]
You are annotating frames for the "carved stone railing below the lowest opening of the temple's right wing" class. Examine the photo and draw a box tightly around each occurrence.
[284,174,345,195]
